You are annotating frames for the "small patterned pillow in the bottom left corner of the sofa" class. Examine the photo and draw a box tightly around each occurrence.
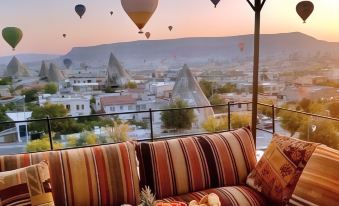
[0,162,54,206]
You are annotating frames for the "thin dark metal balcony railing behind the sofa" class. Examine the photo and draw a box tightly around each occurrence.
[0,102,339,153]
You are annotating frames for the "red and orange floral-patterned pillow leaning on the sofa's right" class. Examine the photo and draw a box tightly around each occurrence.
[247,134,319,205]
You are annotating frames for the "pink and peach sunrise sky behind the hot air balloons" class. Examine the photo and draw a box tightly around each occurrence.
[0,0,339,56]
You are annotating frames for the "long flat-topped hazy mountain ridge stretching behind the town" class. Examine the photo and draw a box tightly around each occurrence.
[61,32,339,69]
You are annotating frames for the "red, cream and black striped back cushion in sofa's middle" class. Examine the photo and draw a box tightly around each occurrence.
[137,128,256,199]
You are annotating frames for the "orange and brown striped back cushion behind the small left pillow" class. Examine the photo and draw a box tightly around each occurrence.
[0,143,139,206]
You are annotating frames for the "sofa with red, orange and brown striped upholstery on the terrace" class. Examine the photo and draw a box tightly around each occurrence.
[0,128,339,206]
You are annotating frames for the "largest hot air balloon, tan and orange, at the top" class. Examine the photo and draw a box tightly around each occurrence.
[121,0,158,34]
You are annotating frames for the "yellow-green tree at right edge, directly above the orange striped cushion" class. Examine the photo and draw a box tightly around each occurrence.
[299,119,339,149]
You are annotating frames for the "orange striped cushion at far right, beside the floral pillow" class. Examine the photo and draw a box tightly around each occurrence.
[289,146,339,205]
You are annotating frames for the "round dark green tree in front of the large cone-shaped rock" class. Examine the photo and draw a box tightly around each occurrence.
[161,99,195,129]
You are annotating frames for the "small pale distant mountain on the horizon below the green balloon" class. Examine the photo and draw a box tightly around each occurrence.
[0,54,60,64]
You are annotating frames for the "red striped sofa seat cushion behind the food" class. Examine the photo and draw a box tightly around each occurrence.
[163,186,266,206]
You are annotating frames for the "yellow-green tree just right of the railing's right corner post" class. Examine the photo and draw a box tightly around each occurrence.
[279,110,307,137]
